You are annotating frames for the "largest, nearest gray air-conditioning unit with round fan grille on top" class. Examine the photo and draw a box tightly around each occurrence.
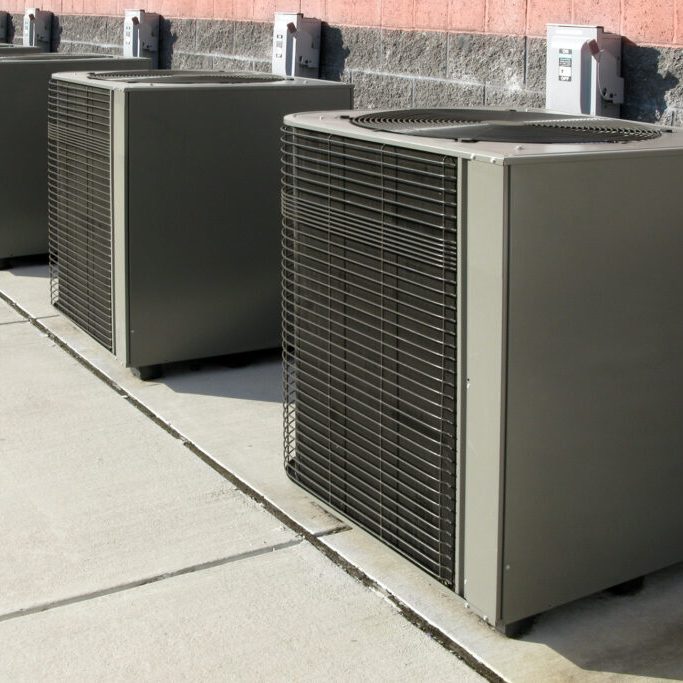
[283,110,683,632]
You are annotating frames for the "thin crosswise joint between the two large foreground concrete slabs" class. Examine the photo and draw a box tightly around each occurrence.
[0,538,303,622]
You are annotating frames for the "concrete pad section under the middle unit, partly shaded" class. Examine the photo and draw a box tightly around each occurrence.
[41,316,344,534]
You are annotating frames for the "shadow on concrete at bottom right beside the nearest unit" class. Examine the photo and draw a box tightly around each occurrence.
[520,564,683,681]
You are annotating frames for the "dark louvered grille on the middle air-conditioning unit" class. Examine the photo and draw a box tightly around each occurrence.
[48,80,114,351]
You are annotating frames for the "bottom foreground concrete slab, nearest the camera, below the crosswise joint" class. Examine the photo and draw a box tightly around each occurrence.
[0,542,482,682]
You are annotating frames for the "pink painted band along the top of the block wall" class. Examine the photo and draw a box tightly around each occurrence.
[3,0,683,45]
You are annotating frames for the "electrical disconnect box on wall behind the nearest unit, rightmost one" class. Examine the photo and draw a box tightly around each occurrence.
[545,24,624,116]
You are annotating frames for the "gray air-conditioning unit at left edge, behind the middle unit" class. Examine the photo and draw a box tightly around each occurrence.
[0,50,149,268]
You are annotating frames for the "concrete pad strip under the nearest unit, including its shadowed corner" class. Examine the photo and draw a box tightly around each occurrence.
[322,528,683,683]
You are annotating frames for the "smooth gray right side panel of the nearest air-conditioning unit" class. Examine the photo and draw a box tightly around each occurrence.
[503,155,683,622]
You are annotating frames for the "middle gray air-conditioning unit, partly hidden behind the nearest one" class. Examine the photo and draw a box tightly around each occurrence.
[49,71,352,378]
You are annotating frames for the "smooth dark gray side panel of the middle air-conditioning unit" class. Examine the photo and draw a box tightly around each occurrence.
[127,87,350,366]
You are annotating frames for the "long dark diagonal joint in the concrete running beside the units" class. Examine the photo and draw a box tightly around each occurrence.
[0,291,505,683]
